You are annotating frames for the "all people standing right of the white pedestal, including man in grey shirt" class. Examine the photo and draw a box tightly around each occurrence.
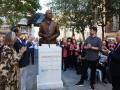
[60,27,120,90]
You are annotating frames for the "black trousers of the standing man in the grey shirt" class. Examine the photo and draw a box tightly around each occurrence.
[80,60,97,85]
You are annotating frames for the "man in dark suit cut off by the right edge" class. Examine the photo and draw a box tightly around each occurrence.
[106,31,120,90]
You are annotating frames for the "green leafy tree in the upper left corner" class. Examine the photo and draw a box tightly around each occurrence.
[0,0,41,24]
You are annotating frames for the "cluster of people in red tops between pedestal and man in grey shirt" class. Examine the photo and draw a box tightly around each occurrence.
[61,38,79,71]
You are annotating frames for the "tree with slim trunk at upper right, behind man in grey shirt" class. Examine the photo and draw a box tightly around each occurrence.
[92,0,120,38]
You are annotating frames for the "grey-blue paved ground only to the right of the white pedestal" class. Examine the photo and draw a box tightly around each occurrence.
[63,70,111,90]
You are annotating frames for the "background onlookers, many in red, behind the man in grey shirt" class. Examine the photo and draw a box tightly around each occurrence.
[60,37,117,78]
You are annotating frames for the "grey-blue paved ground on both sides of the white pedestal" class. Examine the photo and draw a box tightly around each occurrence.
[27,65,112,90]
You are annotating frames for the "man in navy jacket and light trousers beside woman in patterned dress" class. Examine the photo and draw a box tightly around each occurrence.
[11,27,29,90]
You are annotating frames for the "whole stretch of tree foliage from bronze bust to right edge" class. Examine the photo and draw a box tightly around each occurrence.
[49,0,120,36]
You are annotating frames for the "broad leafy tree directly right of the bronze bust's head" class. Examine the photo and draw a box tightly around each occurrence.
[49,0,94,39]
